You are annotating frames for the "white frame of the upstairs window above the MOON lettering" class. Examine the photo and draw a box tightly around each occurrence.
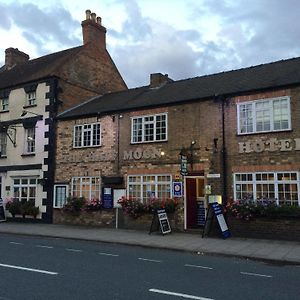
[131,113,168,144]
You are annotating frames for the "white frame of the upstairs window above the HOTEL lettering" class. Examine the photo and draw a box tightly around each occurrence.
[237,96,292,135]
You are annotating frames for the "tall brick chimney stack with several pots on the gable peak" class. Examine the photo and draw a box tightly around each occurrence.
[81,9,106,49]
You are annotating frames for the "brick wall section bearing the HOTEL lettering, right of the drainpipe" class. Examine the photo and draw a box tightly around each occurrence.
[225,88,300,196]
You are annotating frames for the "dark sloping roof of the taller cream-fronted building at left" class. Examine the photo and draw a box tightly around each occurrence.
[0,46,83,89]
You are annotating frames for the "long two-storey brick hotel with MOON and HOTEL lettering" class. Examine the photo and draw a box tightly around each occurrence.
[55,58,300,229]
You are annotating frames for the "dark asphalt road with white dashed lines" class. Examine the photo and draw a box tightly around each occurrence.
[0,234,300,300]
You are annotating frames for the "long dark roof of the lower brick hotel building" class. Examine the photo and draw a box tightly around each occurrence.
[59,57,300,119]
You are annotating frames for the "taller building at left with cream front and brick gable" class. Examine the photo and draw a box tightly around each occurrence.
[0,10,127,222]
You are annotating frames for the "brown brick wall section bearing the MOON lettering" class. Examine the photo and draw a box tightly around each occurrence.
[120,101,222,194]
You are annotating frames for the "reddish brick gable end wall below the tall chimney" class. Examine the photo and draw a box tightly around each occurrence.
[58,44,127,111]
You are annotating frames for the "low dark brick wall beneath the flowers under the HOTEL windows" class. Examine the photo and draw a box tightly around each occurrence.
[224,216,300,241]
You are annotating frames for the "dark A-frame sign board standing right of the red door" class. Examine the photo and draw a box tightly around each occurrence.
[202,202,230,238]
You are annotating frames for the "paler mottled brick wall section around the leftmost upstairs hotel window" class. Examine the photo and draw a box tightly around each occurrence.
[55,116,117,182]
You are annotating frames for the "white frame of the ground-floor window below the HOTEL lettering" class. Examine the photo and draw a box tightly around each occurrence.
[233,171,300,206]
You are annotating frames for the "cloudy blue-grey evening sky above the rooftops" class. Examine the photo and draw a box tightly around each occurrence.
[0,0,300,88]
